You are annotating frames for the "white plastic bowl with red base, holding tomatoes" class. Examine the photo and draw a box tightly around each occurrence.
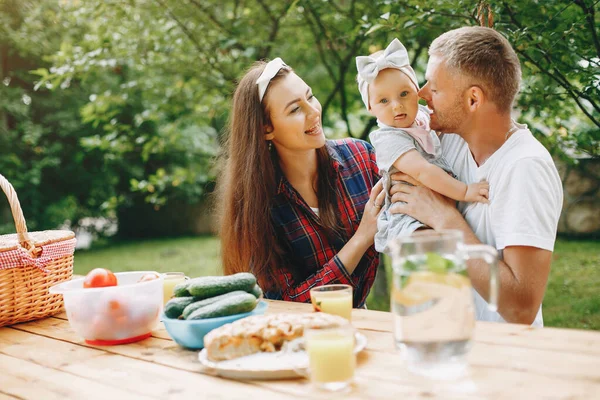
[50,271,163,346]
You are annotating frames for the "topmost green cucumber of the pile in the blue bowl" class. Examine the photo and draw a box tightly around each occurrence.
[186,272,256,299]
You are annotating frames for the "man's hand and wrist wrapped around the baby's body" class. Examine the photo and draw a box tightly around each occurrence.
[390,172,462,229]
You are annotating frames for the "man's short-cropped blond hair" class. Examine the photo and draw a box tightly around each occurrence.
[429,26,521,112]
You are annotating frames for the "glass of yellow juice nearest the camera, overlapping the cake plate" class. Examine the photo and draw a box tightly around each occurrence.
[304,323,356,391]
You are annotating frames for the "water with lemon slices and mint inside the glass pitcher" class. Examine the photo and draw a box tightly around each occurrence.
[391,253,475,378]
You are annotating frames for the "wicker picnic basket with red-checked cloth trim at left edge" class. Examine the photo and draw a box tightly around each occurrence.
[0,175,75,326]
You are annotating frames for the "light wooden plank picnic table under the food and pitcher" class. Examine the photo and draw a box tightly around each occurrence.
[0,301,600,400]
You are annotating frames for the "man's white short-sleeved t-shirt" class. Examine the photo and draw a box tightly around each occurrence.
[442,124,563,327]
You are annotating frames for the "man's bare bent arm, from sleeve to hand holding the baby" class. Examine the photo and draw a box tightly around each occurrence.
[390,174,552,324]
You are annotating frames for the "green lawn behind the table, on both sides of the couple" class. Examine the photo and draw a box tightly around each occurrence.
[75,236,600,330]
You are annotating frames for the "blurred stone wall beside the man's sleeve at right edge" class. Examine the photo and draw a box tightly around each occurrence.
[556,159,600,239]
